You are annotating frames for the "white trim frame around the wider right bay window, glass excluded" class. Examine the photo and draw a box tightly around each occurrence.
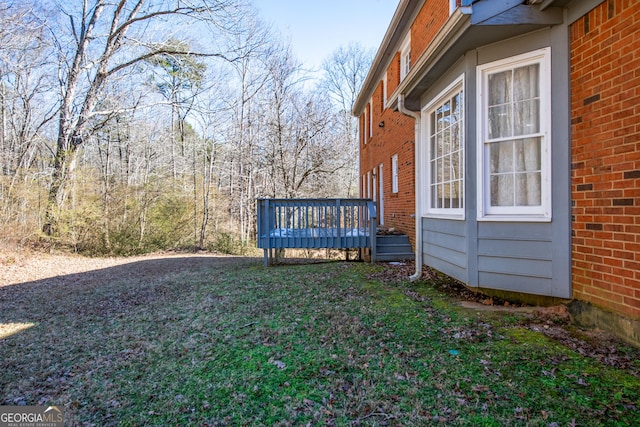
[476,47,552,222]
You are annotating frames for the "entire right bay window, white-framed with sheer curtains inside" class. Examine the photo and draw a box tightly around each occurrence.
[477,48,551,220]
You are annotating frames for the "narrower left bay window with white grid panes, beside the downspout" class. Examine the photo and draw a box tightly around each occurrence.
[424,77,465,216]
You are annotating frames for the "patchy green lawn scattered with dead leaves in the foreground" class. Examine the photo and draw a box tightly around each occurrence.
[0,259,640,426]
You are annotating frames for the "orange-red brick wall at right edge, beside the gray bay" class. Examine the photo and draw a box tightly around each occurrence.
[570,0,640,319]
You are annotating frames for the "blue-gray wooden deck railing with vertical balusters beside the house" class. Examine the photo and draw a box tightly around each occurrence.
[257,199,378,265]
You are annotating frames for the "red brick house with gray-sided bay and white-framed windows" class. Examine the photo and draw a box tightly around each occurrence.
[353,0,640,342]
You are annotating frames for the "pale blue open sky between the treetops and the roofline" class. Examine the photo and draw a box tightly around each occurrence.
[254,0,399,69]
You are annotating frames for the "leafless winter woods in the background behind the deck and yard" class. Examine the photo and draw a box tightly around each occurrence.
[0,0,372,255]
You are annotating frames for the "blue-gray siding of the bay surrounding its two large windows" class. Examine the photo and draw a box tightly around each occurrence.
[421,24,571,298]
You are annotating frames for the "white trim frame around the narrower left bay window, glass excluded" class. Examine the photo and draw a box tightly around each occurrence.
[421,74,467,220]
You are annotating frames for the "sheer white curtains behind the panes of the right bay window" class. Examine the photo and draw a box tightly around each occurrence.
[487,64,542,206]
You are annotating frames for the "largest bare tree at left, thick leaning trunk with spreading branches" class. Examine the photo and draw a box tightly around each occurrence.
[43,0,245,235]
